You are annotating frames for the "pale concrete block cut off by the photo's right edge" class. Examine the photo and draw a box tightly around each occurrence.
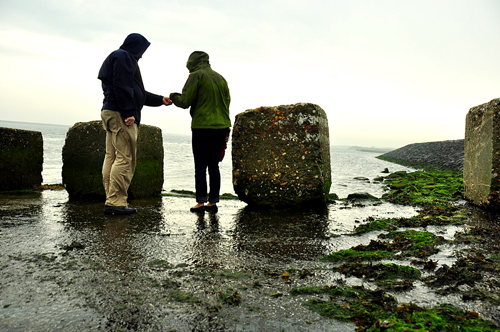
[464,99,500,210]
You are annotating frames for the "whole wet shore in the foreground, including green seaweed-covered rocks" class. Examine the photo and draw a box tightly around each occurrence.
[0,167,500,332]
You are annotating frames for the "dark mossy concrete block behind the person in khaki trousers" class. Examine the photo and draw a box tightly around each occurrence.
[62,121,163,199]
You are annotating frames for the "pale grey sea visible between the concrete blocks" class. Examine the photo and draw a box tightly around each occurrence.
[0,121,413,198]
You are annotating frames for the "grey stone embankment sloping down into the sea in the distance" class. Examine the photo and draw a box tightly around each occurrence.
[380,139,464,171]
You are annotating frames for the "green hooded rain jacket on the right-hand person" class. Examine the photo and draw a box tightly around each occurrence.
[170,51,231,129]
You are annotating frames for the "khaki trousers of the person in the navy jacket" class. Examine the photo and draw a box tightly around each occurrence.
[101,110,138,206]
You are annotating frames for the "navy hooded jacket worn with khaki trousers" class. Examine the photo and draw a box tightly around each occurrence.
[97,33,163,125]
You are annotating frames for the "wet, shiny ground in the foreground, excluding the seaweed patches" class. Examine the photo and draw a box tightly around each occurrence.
[0,190,494,331]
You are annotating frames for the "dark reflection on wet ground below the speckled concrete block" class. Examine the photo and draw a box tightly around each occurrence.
[233,207,329,260]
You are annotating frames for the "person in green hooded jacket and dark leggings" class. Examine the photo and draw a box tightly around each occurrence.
[170,51,231,212]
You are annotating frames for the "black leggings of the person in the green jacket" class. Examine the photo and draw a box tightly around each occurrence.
[192,129,228,203]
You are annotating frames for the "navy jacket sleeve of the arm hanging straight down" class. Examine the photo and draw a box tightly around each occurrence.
[113,52,137,119]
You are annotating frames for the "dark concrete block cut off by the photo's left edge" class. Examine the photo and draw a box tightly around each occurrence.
[0,127,43,191]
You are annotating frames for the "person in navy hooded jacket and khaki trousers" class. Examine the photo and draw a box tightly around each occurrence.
[98,33,172,214]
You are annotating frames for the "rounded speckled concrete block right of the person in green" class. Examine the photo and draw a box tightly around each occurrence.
[232,104,331,208]
